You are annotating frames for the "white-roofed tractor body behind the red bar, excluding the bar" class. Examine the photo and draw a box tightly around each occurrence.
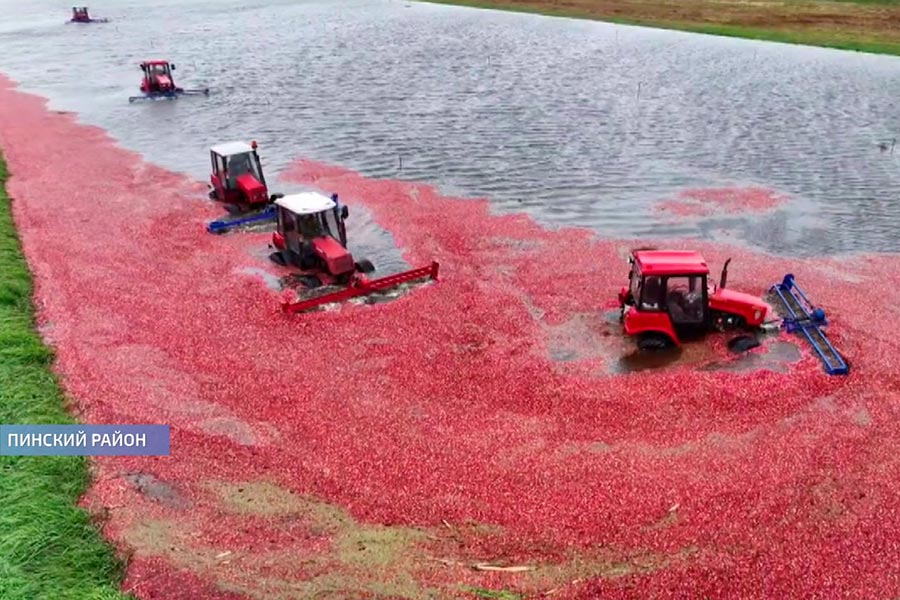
[272,192,374,283]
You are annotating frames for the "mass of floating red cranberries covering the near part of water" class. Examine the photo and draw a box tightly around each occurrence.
[0,69,900,599]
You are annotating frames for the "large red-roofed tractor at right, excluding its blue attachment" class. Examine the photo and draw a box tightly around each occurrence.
[619,250,769,350]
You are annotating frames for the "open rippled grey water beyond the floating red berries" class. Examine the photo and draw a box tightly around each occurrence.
[0,0,900,262]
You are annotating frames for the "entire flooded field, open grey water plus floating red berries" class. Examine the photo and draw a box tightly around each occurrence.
[0,0,900,600]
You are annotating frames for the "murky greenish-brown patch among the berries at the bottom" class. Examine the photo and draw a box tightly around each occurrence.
[155,481,697,600]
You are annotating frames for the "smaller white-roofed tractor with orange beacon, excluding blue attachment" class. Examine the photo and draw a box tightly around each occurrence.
[209,142,270,206]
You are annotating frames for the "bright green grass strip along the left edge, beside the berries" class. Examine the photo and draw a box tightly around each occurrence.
[0,156,128,600]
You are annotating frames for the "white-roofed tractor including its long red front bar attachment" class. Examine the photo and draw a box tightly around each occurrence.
[270,192,438,312]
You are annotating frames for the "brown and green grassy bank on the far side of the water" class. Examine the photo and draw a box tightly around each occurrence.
[424,0,900,55]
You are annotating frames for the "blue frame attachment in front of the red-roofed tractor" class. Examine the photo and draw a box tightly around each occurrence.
[772,274,850,375]
